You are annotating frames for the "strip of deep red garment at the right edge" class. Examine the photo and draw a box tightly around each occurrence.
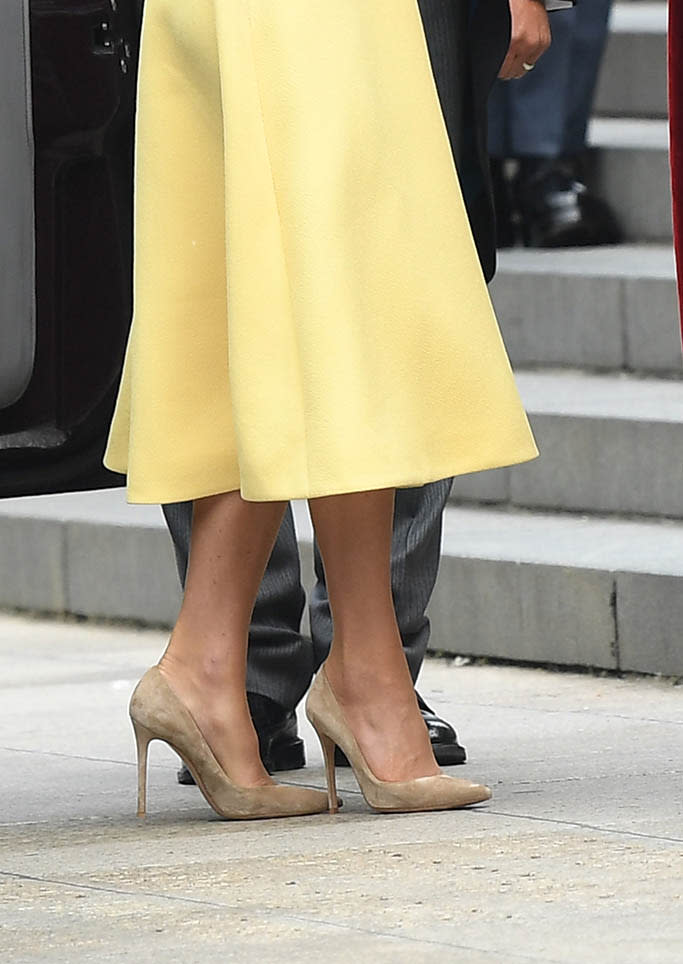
[669,0,683,336]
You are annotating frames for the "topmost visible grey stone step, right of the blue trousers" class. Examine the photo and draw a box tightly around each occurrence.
[595,0,667,118]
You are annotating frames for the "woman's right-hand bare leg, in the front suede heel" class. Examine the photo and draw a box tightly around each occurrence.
[309,489,439,780]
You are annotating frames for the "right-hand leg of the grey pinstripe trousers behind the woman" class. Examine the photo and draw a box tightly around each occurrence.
[310,479,453,681]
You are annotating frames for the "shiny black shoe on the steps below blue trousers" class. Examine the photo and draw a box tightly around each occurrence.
[513,156,622,248]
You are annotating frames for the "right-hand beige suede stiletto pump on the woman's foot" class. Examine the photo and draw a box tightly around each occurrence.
[306,667,491,813]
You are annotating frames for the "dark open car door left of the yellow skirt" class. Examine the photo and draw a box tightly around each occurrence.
[0,0,142,496]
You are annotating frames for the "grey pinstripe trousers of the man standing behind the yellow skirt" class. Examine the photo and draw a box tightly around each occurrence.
[163,0,468,707]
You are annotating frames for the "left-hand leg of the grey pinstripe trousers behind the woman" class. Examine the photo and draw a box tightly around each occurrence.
[163,502,314,709]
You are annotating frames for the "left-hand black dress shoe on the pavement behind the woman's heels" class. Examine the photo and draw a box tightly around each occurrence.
[178,693,306,786]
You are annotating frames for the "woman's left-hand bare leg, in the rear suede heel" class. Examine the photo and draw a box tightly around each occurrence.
[159,492,286,786]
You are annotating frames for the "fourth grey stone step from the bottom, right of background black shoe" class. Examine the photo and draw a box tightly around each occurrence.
[588,118,672,241]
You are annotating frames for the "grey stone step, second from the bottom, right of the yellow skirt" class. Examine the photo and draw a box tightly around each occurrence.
[453,371,683,519]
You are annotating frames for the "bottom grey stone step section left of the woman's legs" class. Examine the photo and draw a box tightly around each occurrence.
[0,489,180,626]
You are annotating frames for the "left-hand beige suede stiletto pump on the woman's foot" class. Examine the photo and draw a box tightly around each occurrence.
[130,666,328,820]
